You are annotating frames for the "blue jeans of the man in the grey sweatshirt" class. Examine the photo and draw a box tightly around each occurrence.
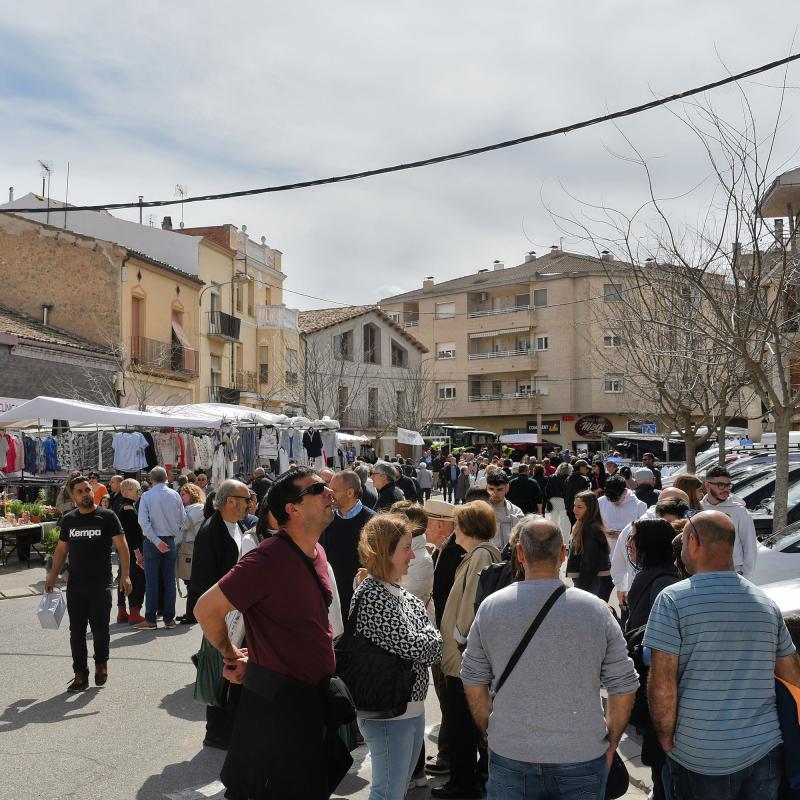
[486,753,608,800]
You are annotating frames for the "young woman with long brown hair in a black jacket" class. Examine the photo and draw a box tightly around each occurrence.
[567,490,613,602]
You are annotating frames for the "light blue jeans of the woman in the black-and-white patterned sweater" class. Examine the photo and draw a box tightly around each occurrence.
[358,714,425,800]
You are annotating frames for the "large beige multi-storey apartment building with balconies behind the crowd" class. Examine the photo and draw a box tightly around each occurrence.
[379,246,644,449]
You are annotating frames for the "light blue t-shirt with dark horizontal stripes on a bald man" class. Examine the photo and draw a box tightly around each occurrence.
[644,572,795,775]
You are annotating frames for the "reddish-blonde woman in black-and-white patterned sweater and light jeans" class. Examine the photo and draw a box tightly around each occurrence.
[350,512,442,800]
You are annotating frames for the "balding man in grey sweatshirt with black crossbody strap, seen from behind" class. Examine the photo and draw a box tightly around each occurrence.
[461,519,639,800]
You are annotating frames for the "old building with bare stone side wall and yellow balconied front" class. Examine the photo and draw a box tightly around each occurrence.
[0,208,202,406]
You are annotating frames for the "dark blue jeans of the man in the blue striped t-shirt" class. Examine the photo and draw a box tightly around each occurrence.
[665,745,783,800]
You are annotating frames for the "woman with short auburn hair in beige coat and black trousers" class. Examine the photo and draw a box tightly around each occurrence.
[438,500,500,797]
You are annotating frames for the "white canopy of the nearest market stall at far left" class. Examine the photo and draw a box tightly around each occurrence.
[0,396,222,428]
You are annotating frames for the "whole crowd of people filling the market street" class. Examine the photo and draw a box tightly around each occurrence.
[46,452,800,800]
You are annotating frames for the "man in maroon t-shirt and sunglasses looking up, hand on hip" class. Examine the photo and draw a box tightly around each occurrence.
[192,467,352,800]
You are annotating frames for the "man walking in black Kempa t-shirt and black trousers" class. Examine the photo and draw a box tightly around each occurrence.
[44,475,132,692]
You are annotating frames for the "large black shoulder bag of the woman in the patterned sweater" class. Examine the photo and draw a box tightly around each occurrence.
[336,595,414,719]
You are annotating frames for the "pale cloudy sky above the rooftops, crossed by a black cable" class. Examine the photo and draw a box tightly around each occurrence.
[0,0,800,309]
